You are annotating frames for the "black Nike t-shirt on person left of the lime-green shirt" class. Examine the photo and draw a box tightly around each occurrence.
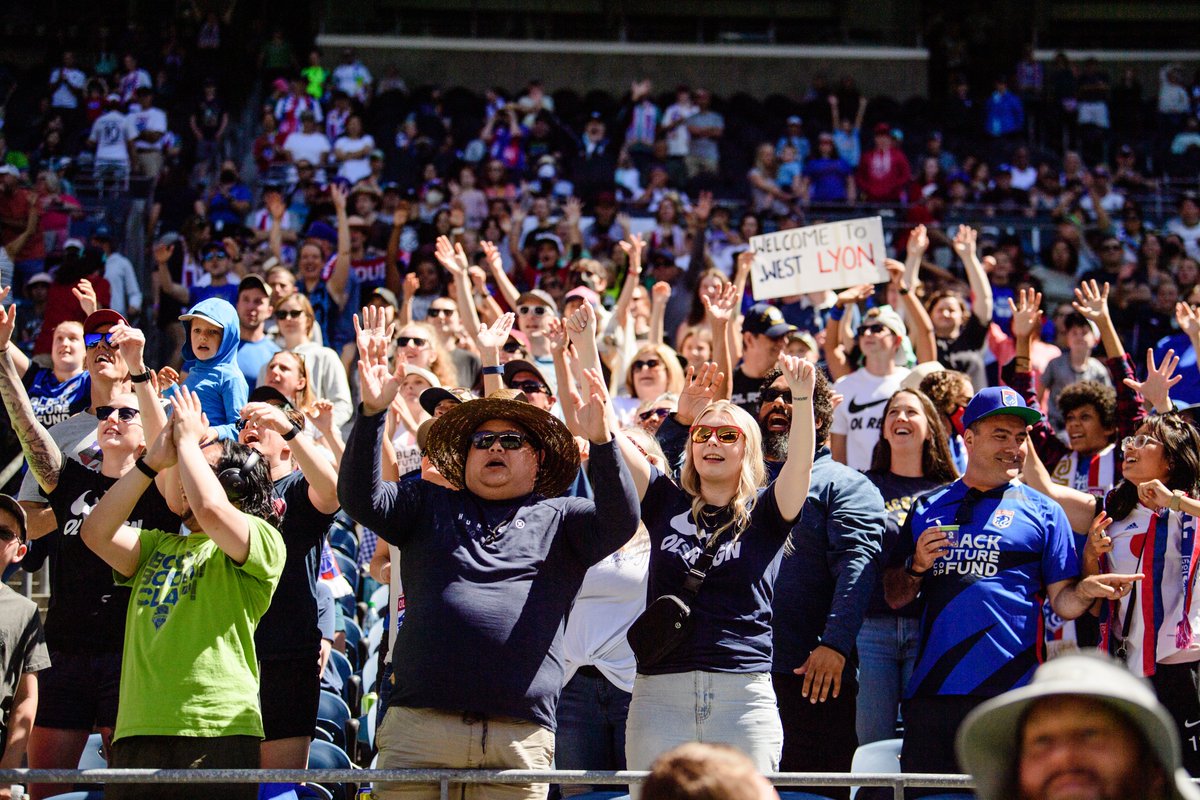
[38,458,180,652]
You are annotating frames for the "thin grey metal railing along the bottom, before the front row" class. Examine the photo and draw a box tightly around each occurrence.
[0,769,974,800]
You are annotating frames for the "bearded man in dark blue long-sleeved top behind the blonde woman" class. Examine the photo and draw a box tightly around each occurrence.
[757,369,887,798]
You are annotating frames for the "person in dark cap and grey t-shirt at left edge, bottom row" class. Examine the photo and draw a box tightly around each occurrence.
[0,494,50,770]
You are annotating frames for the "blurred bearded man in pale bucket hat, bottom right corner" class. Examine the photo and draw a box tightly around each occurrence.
[958,654,1200,800]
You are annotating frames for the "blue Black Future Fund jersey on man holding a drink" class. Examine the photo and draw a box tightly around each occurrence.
[890,481,1079,698]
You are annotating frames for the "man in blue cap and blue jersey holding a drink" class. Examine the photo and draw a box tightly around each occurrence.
[883,386,1141,794]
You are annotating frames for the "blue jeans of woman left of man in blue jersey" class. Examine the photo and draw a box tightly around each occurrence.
[857,616,920,745]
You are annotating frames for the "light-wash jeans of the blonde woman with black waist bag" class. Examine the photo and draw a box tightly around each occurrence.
[625,670,784,800]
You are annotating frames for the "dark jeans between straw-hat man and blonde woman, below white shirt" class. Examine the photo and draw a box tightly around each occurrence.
[554,668,632,796]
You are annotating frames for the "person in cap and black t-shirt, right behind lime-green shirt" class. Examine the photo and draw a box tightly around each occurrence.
[238,386,338,769]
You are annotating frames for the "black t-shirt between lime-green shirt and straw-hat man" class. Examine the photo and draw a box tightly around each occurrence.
[254,470,334,660]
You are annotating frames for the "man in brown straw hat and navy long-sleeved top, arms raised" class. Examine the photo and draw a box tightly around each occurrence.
[338,307,638,800]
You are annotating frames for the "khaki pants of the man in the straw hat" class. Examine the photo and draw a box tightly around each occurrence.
[374,705,554,800]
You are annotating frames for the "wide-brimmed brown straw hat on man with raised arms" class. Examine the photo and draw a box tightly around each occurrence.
[426,397,580,498]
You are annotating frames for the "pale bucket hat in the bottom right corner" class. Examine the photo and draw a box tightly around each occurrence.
[956,654,1200,800]
